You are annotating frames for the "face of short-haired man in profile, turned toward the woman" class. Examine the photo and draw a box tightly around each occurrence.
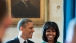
[22,22,34,38]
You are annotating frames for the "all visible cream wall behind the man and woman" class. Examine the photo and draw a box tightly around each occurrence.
[3,0,63,43]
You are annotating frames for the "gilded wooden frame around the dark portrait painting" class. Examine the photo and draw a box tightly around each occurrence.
[7,0,48,25]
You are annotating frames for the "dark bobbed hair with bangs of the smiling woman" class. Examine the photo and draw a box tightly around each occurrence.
[42,21,60,43]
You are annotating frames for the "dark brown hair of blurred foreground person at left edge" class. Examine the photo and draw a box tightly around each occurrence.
[0,0,7,23]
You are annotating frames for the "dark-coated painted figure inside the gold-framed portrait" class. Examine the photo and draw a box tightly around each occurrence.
[12,0,40,18]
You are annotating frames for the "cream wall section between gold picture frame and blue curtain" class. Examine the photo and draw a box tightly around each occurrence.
[49,0,64,42]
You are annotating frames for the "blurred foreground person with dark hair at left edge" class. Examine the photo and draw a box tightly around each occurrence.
[0,0,11,43]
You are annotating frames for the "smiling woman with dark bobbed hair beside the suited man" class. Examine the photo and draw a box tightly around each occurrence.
[42,22,60,43]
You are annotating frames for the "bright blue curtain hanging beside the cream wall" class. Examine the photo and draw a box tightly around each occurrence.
[63,0,76,43]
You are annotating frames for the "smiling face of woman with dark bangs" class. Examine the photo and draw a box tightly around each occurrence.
[46,27,56,41]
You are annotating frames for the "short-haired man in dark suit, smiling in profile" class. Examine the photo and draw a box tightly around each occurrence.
[6,19,34,43]
